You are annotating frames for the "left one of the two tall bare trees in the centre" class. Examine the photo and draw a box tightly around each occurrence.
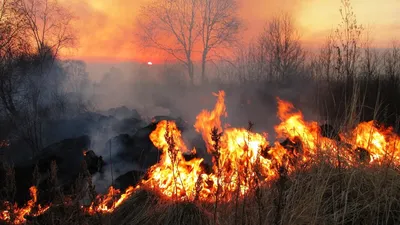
[137,0,200,83]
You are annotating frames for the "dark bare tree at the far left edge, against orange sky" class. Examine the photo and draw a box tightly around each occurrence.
[0,0,74,154]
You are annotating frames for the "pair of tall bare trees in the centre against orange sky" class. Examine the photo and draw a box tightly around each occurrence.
[137,0,239,84]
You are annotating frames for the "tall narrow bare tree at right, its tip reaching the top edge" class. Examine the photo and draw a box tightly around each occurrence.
[315,0,366,126]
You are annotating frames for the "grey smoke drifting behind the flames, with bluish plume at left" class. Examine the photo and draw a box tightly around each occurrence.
[0,55,316,192]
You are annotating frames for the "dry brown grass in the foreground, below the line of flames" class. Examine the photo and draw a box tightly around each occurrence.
[105,164,400,225]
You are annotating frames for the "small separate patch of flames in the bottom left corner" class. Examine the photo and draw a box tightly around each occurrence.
[0,186,50,224]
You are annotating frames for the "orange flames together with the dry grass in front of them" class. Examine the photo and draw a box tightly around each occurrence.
[1,91,400,224]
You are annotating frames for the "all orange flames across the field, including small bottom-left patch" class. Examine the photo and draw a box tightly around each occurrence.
[0,91,400,221]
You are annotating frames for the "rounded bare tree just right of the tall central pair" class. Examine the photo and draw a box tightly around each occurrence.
[235,14,305,83]
